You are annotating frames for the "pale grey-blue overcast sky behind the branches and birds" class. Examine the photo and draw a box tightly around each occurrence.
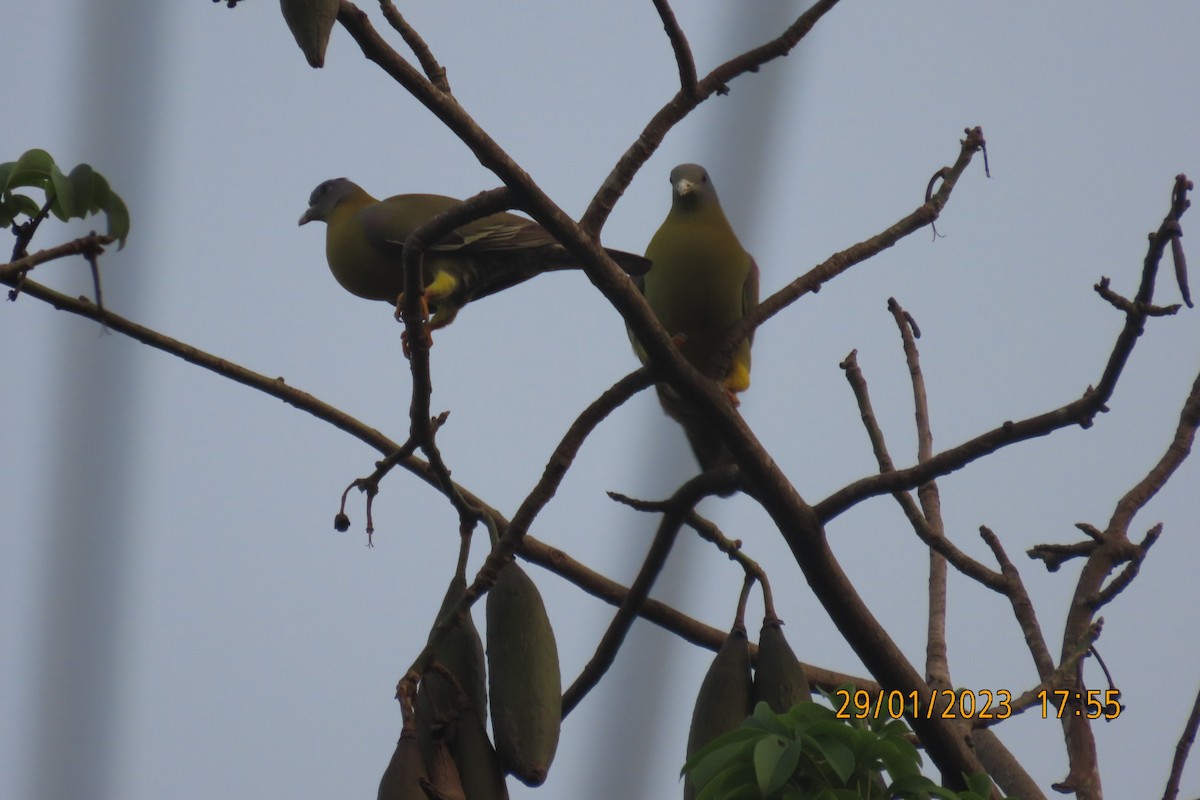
[0,0,1200,800]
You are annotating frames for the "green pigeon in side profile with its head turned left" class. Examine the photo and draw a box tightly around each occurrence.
[300,178,650,331]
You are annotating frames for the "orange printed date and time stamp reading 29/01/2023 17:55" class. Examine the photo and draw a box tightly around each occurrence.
[833,688,1122,721]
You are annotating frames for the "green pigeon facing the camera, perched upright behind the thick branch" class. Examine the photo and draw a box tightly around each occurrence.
[634,164,758,470]
